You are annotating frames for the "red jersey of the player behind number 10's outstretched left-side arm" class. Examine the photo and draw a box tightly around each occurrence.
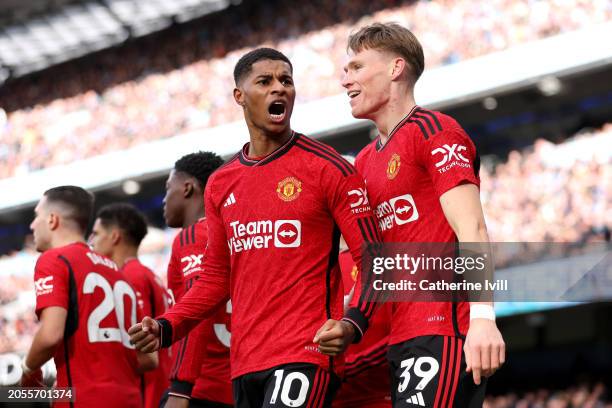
[168,219,233,404]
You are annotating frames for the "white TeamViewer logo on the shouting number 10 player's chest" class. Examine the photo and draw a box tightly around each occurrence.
[227,220,302,255]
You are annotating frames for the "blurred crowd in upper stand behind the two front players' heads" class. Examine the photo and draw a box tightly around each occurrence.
[0,0,612,178]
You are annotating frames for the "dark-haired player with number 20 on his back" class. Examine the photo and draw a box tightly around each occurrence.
[21,186,151,408]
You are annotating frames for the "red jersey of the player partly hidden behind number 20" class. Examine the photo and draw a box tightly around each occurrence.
[121,258,172,408]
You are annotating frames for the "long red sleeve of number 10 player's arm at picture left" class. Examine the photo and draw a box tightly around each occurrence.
[159,176,230,347]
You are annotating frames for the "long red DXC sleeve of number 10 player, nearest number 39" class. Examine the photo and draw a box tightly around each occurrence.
[323,166,382,341]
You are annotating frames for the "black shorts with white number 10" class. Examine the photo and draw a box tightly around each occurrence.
[232,363,340,408]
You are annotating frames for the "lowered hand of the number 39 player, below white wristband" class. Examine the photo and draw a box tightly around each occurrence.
[463,319,506,385]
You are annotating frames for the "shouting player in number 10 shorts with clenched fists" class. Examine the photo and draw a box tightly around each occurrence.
[130,48,379,407]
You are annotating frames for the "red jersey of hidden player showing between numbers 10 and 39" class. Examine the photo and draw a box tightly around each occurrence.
[332,251,391,408]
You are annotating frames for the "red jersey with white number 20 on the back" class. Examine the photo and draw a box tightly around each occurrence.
[34,243,142,408]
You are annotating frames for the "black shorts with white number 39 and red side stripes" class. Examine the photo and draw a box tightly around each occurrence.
[387,336,486,408]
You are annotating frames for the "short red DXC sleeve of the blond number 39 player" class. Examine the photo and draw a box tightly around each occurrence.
[417,125,480,197]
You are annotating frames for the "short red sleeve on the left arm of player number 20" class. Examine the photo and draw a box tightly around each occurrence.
[34,252,69,318]
